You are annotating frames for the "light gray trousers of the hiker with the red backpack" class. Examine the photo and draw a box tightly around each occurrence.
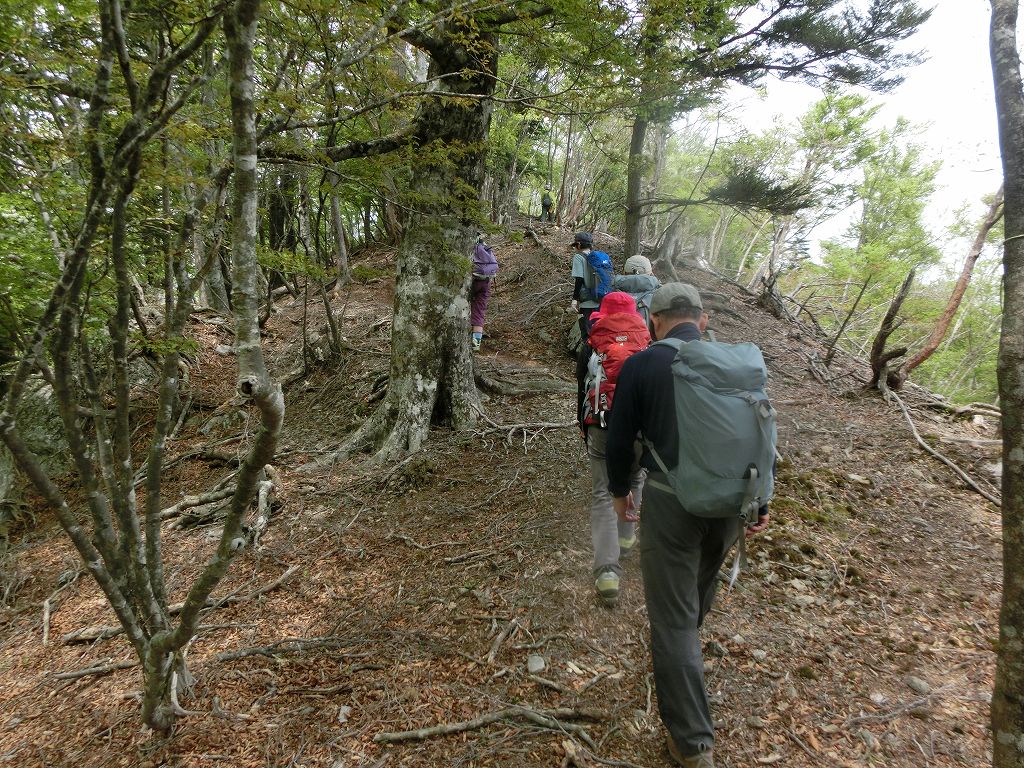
[587,427,647,575]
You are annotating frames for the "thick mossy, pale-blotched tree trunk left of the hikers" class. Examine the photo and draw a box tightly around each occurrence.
[344,16,498,461]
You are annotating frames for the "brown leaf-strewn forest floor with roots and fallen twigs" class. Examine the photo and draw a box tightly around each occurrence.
[0,219,1000,768]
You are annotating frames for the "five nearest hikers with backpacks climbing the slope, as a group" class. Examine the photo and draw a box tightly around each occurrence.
[460,232,776,768]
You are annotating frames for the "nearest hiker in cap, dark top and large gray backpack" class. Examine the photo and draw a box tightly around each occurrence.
[605,283,776,768]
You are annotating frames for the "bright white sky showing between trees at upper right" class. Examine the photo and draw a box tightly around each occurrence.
[730,0,1001,246]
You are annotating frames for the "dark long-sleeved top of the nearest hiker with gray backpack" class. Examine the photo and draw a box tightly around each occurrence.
[604,322,700,496]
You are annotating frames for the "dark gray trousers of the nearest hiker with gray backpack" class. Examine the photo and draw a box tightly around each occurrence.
[640,479,742,757]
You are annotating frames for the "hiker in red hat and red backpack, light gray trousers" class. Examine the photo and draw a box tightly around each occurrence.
[583,291,650,605]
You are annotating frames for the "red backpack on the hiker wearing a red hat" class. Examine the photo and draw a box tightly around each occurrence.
[584,311,650,428]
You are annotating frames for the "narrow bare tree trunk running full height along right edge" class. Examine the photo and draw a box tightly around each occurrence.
[989,0,1024,768]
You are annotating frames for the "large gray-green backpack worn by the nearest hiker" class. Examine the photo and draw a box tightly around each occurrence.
[645,339,777,523]
